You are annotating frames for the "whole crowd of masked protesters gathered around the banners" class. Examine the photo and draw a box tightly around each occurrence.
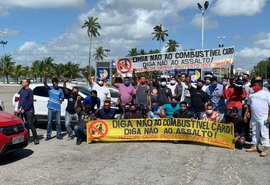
[18,70,270,157]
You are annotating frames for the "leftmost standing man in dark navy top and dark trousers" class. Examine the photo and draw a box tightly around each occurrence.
[17,78,39,145]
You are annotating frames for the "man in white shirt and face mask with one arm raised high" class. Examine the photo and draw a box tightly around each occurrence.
[83,71,111,106]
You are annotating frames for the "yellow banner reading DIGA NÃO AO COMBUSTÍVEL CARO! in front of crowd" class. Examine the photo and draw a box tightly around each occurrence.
[86,118,234,149]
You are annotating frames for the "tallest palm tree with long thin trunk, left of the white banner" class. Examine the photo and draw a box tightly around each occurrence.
[82,17,101,76]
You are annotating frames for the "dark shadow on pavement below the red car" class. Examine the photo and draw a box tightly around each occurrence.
[0,149,34,166]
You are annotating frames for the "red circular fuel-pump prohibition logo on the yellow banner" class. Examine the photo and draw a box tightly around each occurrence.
[87,120,108,139]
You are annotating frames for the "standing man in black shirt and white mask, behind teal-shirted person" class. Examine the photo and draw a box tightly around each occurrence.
[157,78,172,106]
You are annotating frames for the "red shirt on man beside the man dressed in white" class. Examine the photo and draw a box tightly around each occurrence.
[223,87,247,109]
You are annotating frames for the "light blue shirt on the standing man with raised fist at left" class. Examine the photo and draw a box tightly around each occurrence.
[47,86,64,111]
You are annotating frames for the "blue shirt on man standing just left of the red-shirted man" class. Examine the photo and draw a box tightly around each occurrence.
[205,84,226,111]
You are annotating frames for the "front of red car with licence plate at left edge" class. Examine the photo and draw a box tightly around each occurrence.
[0,111,28,156]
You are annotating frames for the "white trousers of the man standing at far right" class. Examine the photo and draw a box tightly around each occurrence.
[250,118,270,147]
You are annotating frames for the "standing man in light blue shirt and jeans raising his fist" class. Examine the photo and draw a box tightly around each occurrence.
[43,73,64,141]
